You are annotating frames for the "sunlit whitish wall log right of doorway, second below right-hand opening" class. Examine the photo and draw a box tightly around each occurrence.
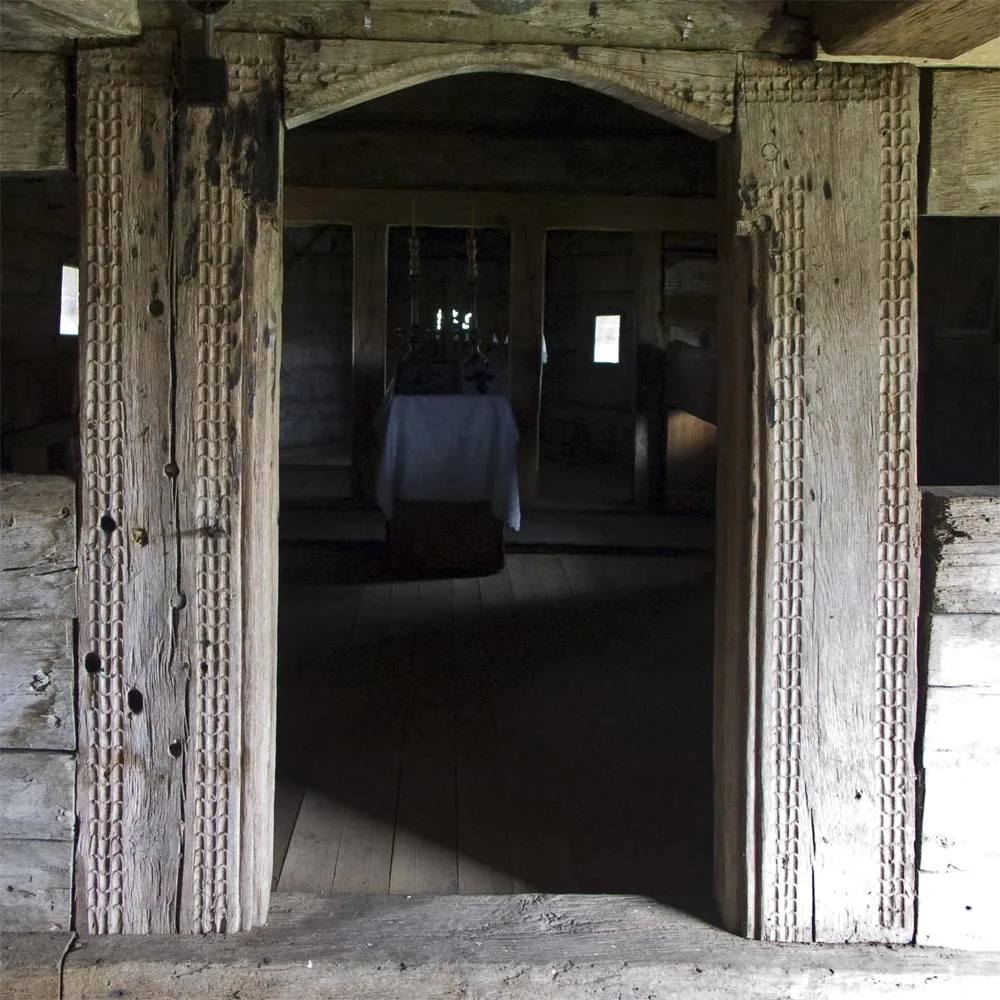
[926,613,1000,694]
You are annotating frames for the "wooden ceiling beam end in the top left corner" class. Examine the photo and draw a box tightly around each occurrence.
[0,0,142,50]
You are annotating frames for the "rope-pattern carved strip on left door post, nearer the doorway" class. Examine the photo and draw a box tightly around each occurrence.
[191,158,235,932]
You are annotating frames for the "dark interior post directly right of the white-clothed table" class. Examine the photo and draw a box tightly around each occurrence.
[509,229,545,500]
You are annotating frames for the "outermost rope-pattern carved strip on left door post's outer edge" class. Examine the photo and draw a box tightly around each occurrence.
[80,72,126,934]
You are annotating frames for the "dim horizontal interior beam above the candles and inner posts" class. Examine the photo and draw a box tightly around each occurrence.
[285,187,718,233]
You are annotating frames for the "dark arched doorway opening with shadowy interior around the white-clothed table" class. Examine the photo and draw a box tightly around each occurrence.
[273,73,715,918]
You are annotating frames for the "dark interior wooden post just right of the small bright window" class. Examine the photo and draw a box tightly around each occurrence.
[632,233,666,504]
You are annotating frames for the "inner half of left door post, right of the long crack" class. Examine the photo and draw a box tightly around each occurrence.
[175,35,281,932]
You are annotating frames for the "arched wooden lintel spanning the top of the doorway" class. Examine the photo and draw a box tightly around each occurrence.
[285,36,736,139]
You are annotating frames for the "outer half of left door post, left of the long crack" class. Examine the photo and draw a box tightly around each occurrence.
[76,36,183,933]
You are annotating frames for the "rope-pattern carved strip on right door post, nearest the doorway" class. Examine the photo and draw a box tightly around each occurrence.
[764,176,806,941]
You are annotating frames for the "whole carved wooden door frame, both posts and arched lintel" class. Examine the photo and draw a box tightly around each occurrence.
[77,41,919,941]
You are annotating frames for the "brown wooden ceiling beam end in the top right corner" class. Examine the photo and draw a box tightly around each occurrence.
[788,0,1000,59]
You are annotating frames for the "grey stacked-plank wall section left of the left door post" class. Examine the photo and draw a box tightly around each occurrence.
[0,474,76,931]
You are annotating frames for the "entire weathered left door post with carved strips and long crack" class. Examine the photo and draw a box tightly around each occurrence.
[77,35,282,933]
